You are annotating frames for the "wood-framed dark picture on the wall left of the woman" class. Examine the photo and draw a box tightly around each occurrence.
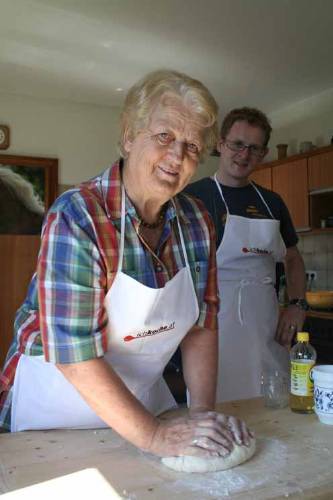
[0,154,58,234]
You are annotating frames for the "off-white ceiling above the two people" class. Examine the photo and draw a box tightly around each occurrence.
[0,0,333,114]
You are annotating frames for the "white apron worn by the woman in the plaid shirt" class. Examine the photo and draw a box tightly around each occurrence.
[11,187,199,432]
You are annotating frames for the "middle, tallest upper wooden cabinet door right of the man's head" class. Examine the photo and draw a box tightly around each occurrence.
[272,158,310,231]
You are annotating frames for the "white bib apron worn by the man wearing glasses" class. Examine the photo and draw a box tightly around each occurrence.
[215,175,289,402]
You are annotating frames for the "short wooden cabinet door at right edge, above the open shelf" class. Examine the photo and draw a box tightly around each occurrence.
[308,151,333,191]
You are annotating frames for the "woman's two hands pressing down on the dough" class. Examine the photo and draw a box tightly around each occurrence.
[147,411,253,457]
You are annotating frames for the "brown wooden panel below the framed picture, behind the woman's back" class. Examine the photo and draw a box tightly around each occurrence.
[0,234,40,370]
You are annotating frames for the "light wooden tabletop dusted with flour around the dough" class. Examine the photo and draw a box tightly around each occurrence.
[0,399,333,500]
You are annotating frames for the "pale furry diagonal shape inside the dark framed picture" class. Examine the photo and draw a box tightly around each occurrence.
[0,166,45,215]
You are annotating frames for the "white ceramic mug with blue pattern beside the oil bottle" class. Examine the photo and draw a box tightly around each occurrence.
[311,365,333,425]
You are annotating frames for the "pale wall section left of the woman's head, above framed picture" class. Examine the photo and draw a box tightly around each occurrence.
[0,93,120,184]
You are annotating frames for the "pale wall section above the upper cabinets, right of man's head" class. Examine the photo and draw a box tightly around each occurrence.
[266,88,333,161]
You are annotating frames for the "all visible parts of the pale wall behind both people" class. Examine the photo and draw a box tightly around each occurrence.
[0,84,333,184]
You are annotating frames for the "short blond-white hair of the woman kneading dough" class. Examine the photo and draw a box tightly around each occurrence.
[119,70,218,158]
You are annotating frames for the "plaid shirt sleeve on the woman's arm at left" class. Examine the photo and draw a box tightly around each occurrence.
[37,197,107,363]
